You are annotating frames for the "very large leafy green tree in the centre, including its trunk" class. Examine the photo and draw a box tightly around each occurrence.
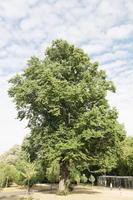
[9,40,125,190]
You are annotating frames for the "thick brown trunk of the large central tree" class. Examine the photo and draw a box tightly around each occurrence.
[59,162,68,191]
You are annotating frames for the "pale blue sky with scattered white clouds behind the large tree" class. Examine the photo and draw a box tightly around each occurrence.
[0,0,133,153]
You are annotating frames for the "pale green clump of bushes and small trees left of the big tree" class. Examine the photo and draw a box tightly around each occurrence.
[0,145,45,187]
